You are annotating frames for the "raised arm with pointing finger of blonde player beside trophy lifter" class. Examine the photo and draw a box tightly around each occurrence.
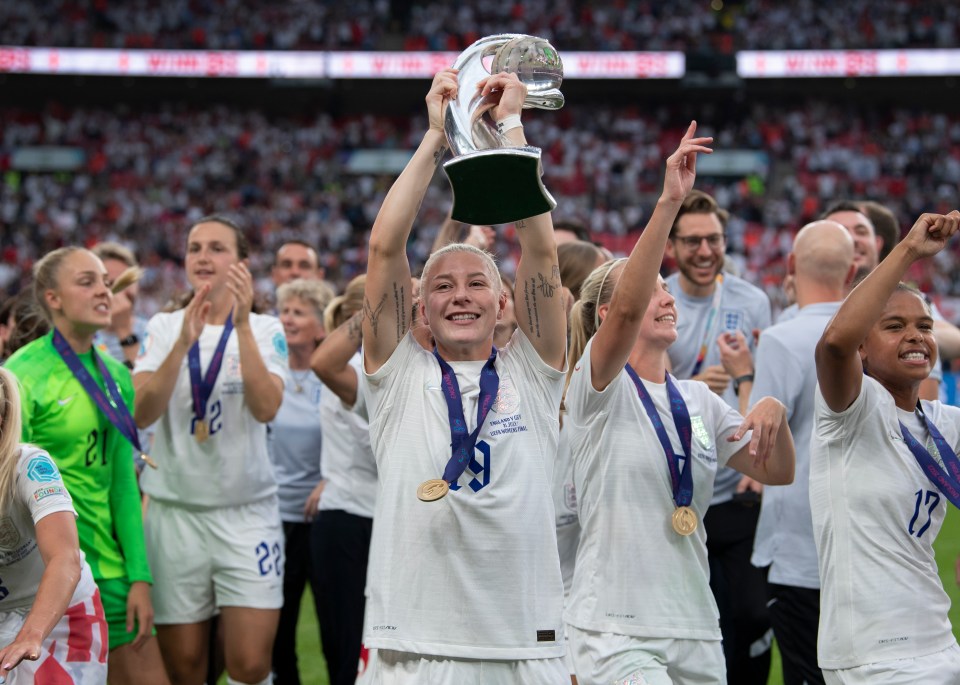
[588,121,713,390]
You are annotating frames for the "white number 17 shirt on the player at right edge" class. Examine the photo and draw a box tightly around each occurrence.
[810,376,960,669]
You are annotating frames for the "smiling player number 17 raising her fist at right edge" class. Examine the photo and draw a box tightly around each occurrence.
[810,210,960,683]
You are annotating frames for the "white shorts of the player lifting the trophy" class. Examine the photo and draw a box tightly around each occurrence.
[365,649,570,685]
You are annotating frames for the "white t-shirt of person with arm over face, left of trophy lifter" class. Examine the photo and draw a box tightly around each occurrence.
[320,352,378,518]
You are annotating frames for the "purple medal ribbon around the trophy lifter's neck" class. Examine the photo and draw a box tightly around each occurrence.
[433,347,500,485]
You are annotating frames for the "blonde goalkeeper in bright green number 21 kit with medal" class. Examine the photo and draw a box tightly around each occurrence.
[6,247,167,685]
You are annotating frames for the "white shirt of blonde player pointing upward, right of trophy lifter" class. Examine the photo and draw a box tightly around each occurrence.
[564,341,749,640]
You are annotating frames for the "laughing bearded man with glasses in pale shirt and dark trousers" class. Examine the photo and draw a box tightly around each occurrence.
[666,190,772,685]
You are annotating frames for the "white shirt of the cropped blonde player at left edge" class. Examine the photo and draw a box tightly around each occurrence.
[0,445,95,613]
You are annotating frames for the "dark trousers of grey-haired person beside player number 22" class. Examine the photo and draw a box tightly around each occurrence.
[273,521,320,685]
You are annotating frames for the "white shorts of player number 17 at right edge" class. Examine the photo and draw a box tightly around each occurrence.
[823,643,960,685]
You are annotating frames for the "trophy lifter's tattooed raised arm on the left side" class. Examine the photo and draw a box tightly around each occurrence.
[363,69,457,373]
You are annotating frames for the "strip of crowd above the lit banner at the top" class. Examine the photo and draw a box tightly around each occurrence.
[0,0,960,53]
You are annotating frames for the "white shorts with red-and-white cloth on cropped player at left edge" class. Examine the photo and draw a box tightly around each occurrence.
[0,582,110,685]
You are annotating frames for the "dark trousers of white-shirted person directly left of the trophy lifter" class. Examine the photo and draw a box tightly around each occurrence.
[313,510,373,685]
